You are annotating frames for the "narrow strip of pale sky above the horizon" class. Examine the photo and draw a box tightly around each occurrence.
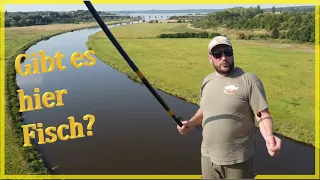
[5,4,312,12]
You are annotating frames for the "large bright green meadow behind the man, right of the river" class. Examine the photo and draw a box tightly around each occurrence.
[87,23,315,145]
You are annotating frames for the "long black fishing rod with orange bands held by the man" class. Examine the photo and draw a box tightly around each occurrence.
[83,0,183,127]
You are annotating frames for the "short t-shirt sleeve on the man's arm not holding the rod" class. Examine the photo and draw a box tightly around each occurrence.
[249,79,269,113]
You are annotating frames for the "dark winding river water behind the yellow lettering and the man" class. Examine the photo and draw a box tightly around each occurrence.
[17,24,315,175]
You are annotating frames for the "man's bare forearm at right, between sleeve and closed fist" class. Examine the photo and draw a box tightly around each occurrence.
[256,108,273,140]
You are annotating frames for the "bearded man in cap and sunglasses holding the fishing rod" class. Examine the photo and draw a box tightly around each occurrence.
[177,36,281,179]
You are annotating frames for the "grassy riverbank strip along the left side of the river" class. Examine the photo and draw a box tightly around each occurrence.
[5,23,125,175]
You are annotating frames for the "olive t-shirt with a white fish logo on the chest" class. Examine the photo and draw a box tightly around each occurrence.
[200,67,268,165]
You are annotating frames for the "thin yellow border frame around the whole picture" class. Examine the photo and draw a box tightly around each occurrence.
[0,0,320,179]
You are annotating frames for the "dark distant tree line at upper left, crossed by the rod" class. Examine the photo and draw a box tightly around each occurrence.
[5,10,130,27]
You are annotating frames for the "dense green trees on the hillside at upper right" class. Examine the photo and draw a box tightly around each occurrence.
[192,6,315,43]
